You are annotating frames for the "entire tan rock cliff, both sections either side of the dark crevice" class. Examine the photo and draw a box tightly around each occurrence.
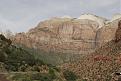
[13,15,121,54]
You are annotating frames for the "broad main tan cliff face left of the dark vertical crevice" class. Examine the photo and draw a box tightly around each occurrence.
[14,18,99,54]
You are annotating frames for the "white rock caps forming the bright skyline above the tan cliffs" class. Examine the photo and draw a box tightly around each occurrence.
[49,13,121,28]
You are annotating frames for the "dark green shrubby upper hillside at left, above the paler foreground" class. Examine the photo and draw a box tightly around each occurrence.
[0,35,44,71]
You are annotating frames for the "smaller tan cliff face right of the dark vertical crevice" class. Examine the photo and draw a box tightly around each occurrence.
[96,18,121,47]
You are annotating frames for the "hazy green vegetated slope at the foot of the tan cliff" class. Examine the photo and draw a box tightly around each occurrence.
[16,44,82,66]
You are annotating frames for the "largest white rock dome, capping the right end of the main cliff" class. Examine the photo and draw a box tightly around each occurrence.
[78,14,107,28]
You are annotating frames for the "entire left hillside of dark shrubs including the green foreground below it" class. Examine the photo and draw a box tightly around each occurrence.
[0,35,78,81]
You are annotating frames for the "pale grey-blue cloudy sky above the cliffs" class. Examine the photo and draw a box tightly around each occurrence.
[0,0,121,32]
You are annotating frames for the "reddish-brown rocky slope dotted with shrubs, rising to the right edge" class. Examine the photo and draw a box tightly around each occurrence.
[62,20,121,81]
